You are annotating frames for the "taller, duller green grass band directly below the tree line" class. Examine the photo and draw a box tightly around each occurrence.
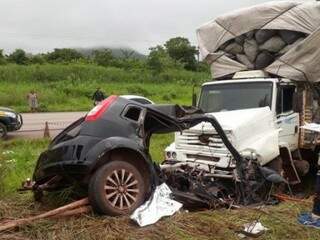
[0,63,209,84]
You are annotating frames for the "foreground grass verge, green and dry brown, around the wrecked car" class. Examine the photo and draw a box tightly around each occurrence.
[0,139,320,240]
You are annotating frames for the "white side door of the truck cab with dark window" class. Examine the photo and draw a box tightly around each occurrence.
[276,85,299,151]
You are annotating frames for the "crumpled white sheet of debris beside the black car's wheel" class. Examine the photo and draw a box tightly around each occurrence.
[130,183,182,227]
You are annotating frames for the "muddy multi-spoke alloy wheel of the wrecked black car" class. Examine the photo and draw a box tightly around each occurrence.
[88,160,147,216]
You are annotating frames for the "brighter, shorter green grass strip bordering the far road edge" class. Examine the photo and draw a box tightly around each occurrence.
[0,82,199,112]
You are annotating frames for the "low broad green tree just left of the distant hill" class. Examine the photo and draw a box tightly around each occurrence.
[45,48,84,62]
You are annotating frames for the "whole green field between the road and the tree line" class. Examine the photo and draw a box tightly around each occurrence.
[0,64,210,112]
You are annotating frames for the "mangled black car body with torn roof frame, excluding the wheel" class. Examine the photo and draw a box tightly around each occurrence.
[33,97,241,191]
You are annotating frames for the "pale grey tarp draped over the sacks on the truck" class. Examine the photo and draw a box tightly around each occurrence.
[197,1,320,82]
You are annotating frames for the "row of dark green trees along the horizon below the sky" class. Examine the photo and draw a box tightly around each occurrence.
[0,37,208,73]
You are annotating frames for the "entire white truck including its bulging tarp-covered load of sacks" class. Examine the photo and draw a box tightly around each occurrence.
[164,1,320,187]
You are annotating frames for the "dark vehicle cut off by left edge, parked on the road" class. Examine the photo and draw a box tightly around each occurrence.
[0,107,23,139]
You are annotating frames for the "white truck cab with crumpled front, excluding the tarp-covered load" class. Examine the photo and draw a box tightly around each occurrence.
[165,71,317,184]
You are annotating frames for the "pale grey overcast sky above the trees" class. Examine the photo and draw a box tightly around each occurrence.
[0,0,276,53]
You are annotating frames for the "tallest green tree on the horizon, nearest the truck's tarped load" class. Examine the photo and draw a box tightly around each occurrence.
[164,37,198,71]
